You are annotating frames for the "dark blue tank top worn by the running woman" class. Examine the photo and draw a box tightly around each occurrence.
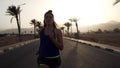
[39,29,60,57]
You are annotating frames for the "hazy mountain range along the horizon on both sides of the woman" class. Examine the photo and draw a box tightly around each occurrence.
[0,20,120,34]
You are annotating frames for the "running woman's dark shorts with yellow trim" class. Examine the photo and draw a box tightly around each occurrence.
[37,57,61,68]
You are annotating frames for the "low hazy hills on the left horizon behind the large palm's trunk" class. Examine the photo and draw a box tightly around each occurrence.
[0,28,33,34]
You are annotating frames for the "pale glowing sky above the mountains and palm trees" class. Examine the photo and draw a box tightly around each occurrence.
[0,0,120,31]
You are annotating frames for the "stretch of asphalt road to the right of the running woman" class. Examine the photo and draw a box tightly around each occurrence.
[61,40,120,68]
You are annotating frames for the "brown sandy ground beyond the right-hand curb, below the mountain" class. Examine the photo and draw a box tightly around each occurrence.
[80,33,120,47]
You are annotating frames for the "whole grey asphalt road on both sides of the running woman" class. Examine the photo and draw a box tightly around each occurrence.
[0,39,120,68]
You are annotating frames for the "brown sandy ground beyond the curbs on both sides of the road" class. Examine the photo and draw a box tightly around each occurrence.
[0,33,120,47]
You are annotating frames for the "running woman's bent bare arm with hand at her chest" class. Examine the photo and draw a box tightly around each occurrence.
[50,29,64,50]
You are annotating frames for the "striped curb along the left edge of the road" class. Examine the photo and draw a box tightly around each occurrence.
[0,39,39,55]
